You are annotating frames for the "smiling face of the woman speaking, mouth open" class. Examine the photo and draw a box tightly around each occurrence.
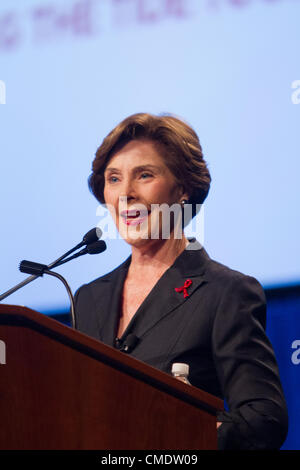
[104,140,188,246]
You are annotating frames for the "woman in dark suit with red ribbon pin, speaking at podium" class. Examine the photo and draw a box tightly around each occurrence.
[75,113,287,449]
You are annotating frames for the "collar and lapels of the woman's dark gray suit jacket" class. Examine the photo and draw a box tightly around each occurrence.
[97,238,210,346]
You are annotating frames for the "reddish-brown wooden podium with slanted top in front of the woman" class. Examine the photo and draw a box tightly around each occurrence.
[0,305,223,450]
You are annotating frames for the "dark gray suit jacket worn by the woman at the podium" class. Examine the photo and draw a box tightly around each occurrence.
[75,239,288,449]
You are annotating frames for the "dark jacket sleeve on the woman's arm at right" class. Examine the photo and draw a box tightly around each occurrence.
[212,275,288,449]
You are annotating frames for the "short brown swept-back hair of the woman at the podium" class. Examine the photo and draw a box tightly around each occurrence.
[88,113,211,216]
